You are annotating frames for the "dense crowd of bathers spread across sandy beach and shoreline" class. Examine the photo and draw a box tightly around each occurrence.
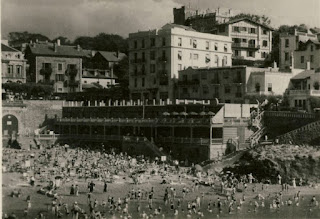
[3,145,318,219]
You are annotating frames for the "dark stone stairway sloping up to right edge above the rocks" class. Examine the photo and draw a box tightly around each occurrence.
[278,120,320,145]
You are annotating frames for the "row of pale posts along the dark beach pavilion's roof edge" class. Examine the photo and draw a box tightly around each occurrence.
[62,99,211,107]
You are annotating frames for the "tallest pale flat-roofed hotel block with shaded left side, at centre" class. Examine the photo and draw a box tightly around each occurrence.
[129,24,232,100]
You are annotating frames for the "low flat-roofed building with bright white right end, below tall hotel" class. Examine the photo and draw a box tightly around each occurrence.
[177,66,302,103]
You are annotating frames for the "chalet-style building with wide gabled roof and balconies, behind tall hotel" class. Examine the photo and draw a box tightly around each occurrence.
[212,18,273,64]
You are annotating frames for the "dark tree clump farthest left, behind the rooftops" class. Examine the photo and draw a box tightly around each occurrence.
[8,31,50,46]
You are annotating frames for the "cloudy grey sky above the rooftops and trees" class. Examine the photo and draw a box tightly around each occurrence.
[1,0,320,40]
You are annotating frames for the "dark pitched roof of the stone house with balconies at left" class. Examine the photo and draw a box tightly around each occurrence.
[29,43,89,57]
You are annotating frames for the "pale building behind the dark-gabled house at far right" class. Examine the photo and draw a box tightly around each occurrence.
[279,29,317,70]
